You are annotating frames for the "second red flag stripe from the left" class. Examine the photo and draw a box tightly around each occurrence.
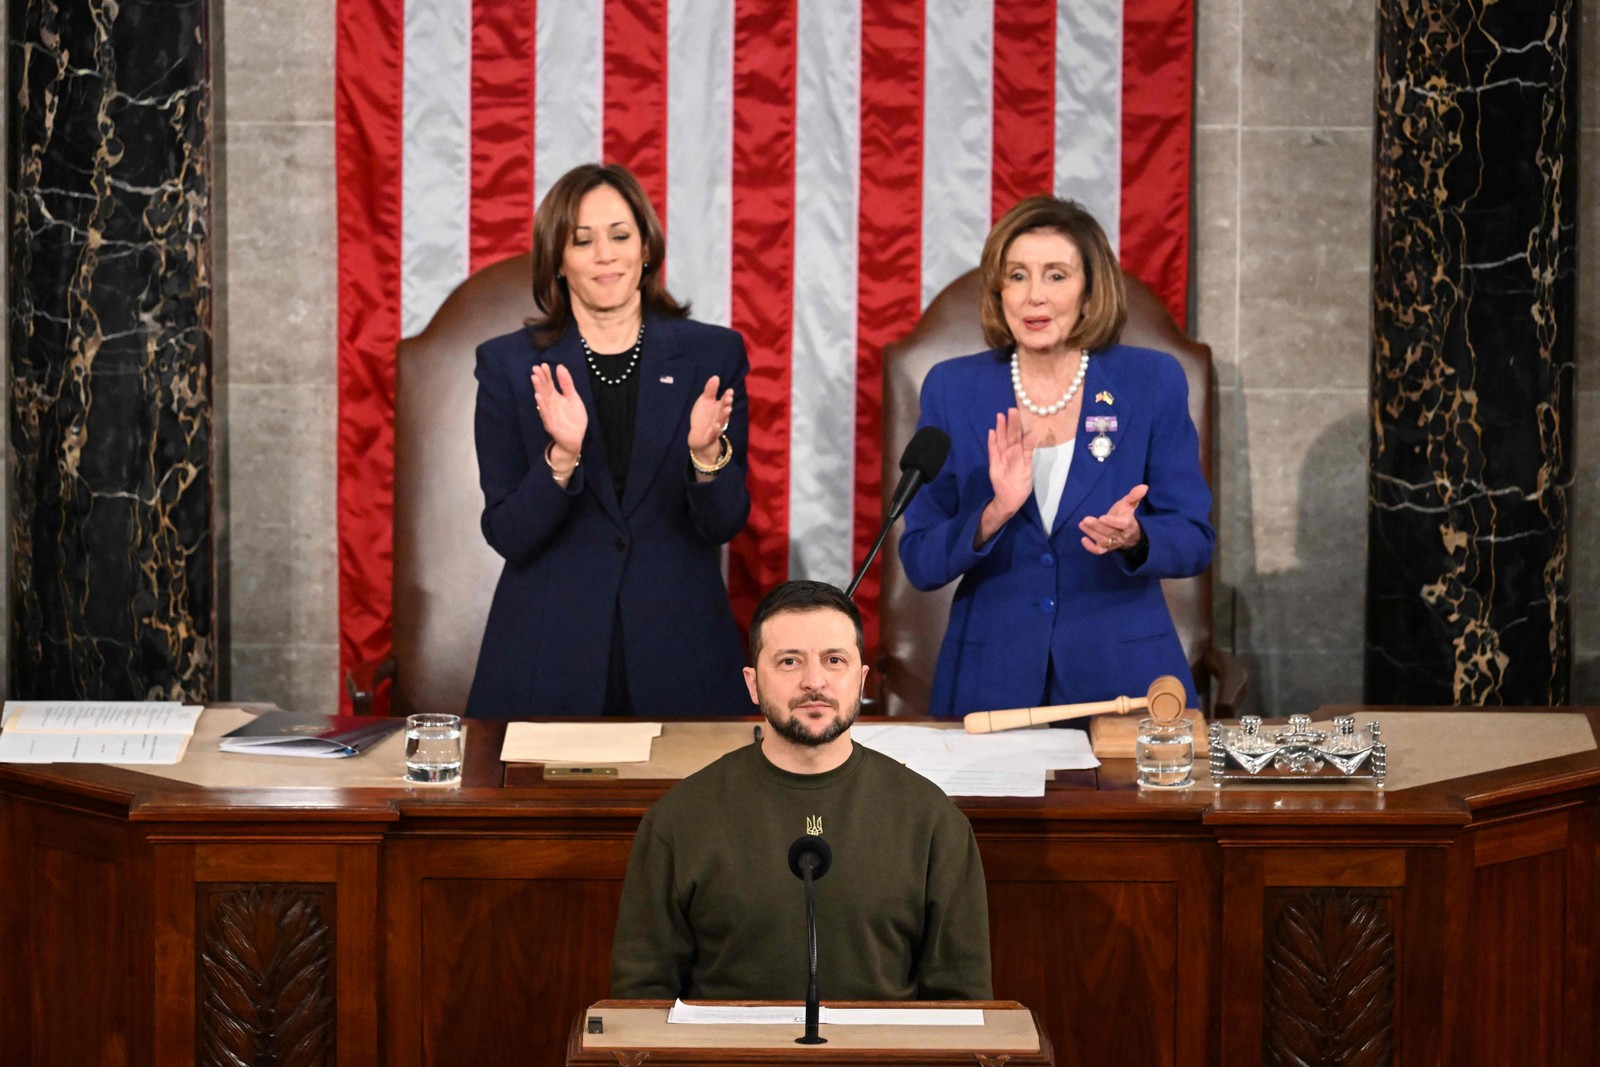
[467,0,538,270]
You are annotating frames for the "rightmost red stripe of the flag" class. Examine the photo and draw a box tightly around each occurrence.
[1120,0,1195,326]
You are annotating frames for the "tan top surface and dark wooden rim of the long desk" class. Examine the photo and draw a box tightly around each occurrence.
[0,707,1600,821]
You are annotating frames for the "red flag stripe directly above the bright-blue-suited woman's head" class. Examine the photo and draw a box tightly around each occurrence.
[989,0,1056,219]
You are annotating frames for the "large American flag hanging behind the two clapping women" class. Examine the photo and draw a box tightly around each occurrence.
[336,0,1194,694]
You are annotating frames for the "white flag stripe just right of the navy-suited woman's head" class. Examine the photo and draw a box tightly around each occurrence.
[664,0,733,326]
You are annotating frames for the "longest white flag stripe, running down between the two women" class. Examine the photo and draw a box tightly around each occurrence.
[789,3,861,585]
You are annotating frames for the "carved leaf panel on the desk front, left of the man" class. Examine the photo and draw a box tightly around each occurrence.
[195,885,334,1067]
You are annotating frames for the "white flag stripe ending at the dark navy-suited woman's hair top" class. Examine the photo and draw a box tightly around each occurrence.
[540,0,605,208]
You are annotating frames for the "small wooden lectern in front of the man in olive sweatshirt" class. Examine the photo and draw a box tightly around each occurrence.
[566,1000,1056,1067]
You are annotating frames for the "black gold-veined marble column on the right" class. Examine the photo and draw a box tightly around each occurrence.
[1366,0,1579,704]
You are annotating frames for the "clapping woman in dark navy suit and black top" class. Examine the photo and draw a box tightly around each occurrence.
[467,165,750,718]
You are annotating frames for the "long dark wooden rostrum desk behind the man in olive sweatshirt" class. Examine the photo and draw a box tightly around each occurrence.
[0,709,1600,1067]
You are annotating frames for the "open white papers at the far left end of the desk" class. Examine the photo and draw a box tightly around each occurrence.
[0,701,200,763]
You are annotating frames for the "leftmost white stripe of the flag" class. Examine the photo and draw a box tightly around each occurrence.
[400,0,472,336]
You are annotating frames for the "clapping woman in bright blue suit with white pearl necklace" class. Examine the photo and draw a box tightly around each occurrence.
[899,197,1214,715]
